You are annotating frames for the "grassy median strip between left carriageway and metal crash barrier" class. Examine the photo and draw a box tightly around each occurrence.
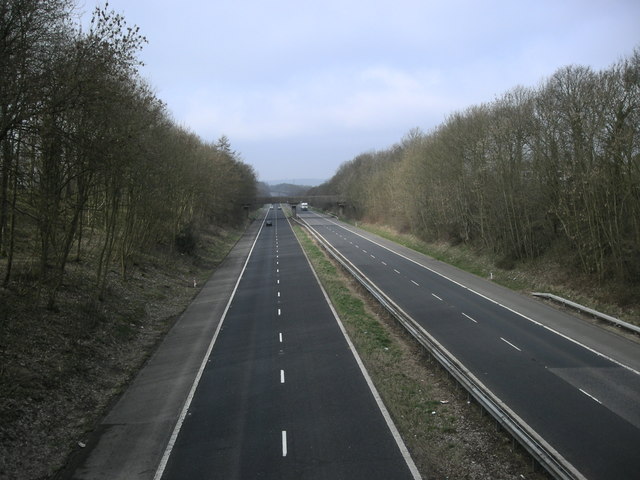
[294,226,546,479]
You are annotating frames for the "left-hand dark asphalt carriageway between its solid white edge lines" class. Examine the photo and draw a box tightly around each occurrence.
[155,208,420,480]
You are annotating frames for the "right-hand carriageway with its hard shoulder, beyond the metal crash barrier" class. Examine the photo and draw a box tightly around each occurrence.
[299,212,640,480]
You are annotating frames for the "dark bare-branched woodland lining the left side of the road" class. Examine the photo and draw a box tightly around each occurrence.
[0,0,256,307]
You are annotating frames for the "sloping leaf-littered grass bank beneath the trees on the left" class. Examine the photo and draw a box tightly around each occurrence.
[0,225,240,480]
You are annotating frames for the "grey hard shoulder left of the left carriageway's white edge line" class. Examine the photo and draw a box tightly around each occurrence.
[57,222,260,479]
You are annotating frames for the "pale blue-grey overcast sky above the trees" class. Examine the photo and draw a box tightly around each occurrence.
[83,0,640,181]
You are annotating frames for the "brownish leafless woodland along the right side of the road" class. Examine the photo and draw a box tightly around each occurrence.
[312,49,640,284]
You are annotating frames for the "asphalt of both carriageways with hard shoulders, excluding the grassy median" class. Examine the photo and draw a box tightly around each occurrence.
[65,208,640,480]
